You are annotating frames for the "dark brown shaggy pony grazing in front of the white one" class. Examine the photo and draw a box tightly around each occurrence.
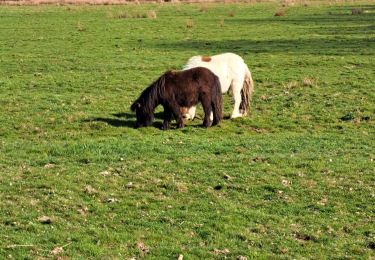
[130,67,222,130]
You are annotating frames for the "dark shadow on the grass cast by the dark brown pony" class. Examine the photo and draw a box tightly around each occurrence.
[83,112,163,128]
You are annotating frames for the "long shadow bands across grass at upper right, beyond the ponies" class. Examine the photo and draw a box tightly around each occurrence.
[156,12,375,55]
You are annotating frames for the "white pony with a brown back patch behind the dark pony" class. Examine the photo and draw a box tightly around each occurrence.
[183,53,254,119]
